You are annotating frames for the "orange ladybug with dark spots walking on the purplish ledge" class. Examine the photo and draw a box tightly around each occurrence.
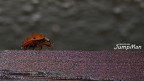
[21,34,53,50]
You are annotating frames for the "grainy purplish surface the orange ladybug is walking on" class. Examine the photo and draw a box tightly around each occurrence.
[0,50,144,81]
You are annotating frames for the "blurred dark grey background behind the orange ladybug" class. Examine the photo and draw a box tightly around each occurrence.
[0,0,144,50]
